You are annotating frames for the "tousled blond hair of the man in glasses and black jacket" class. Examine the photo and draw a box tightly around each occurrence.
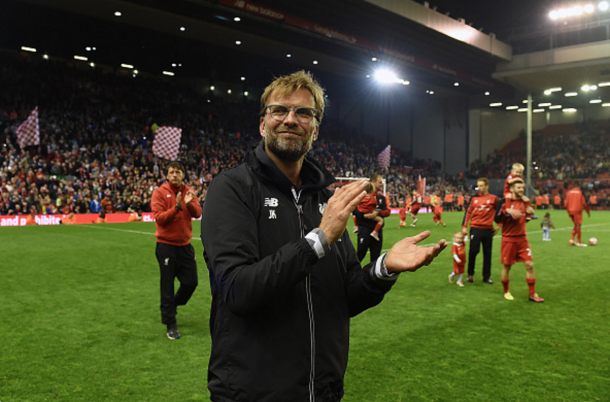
[260,70,325,124]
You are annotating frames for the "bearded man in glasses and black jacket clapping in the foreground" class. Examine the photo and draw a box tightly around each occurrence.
[201,71,447,402]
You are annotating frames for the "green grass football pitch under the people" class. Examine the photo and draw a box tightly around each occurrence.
[0,211,610,402]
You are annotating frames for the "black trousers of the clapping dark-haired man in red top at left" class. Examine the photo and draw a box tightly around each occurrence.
[155,243,199,325]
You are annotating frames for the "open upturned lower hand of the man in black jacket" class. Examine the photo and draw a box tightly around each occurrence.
[385,230,447,273]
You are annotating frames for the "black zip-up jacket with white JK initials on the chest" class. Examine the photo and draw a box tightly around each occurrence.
[201,144,394,402]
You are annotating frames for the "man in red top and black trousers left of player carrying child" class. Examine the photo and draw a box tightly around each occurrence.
[462,177,499,285]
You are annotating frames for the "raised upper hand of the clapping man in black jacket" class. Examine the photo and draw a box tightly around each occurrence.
[320,180,369,244]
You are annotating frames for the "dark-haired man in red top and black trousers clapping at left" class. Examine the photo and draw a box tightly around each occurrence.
[150,162,201,339]
